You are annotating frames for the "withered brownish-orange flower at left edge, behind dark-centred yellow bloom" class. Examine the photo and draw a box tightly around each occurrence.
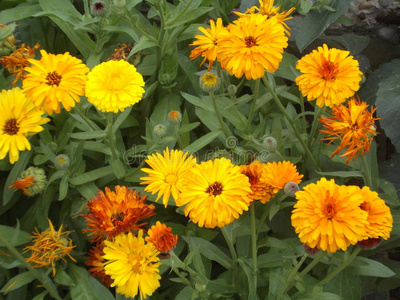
[0,43,40,86]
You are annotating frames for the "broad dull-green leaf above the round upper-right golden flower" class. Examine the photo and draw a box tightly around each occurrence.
[296,0,352,52]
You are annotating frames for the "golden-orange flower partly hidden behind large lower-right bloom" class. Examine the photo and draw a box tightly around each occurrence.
[360,186,393,240]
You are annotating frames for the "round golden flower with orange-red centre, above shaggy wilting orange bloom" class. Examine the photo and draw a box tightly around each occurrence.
[296,44,362,107]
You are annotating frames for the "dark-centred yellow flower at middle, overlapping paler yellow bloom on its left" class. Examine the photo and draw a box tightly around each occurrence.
[177,158,252,228]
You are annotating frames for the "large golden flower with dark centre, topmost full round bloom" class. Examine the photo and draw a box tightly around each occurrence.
[218,14,288,80]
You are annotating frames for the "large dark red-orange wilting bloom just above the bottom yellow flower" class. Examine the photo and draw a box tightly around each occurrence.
[82,185,155,242]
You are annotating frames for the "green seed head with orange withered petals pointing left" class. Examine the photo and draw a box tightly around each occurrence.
[8,167,47,196]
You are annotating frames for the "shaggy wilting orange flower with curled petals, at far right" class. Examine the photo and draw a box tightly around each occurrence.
[319,97,378,164]
